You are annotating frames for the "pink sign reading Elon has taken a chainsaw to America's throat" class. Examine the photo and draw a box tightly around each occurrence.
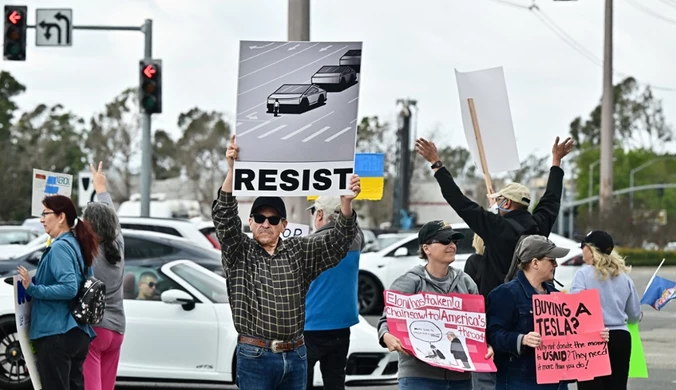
[384,291,497,372]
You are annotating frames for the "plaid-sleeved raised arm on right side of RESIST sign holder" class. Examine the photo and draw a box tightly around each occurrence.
[300,175,361,284]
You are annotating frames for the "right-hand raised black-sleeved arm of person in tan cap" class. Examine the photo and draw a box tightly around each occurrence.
[533,137,574,236]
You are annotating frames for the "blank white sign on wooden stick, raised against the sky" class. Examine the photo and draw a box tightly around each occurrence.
[455,67,521,174]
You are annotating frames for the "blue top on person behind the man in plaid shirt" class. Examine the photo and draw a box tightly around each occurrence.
[305,222,364,331]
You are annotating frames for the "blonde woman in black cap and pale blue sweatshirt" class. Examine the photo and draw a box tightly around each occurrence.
[570,230,642,390]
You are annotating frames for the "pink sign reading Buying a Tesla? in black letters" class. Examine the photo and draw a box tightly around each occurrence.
[533,289,611,384]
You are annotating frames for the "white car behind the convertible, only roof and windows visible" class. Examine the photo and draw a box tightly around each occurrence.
[118,217,214,248]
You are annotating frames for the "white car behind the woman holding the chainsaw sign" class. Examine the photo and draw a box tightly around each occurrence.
[358,223,583,315]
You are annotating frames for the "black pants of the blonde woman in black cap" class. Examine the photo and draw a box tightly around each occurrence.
[577,330,631,390]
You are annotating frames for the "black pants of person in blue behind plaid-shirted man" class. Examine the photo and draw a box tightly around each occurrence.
[303,328,350,390]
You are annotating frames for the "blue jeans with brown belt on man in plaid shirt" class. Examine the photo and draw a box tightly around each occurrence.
[235,343,307,390]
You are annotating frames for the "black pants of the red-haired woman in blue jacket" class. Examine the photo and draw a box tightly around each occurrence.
[34,328,91,390]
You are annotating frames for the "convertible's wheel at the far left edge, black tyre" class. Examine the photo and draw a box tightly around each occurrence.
[0,316,33,390]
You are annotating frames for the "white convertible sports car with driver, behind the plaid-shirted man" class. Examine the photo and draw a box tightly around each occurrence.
[0,260,397,390]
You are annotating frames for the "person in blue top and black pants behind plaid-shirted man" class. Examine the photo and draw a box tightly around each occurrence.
[304,196,364,390]
